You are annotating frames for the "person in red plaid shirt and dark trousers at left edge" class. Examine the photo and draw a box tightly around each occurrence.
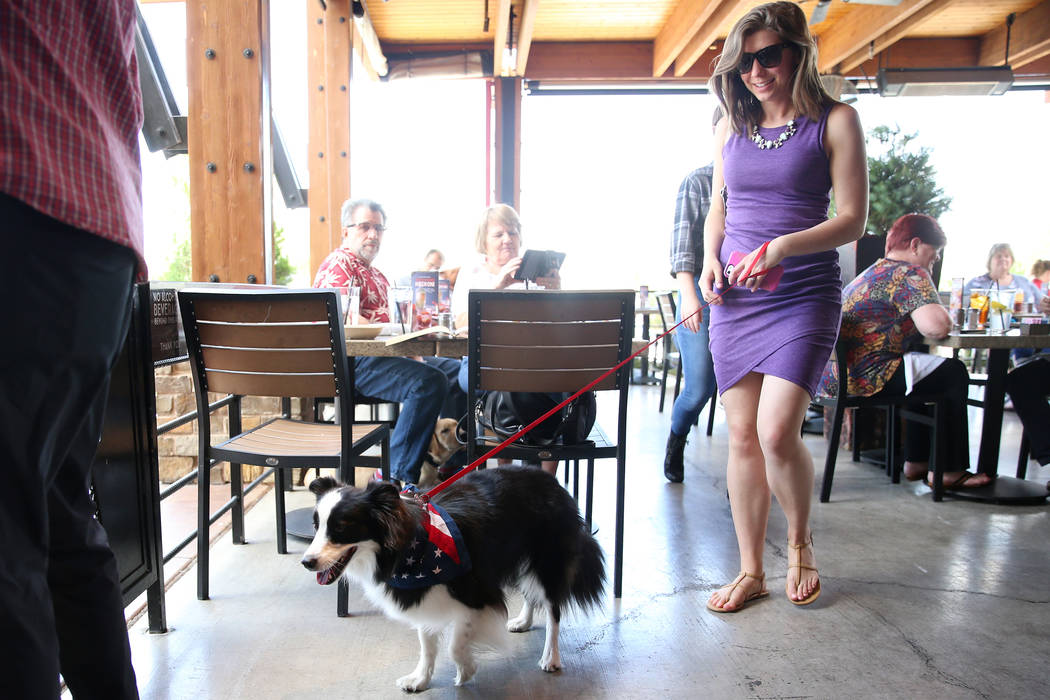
[0,0,146,700]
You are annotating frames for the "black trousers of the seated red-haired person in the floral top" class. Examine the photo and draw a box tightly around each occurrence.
[876,358,970,471]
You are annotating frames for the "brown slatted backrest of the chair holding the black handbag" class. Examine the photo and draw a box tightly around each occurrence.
[468,291,634,391]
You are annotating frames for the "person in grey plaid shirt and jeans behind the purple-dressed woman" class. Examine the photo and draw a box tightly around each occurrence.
[664,108,721,484]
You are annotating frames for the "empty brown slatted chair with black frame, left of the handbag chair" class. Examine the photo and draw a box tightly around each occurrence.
[179,289,390,615]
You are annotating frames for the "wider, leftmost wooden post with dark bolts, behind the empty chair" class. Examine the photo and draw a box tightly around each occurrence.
[186,0,273,283]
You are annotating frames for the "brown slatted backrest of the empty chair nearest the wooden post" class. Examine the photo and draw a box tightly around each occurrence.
[179,290,347,397]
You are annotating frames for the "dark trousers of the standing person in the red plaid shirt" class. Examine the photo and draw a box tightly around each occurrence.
[0,194,138,700]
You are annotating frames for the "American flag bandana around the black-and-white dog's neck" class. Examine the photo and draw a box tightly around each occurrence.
[387,503,470,589]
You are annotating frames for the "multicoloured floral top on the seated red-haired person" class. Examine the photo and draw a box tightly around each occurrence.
[818,258,941,397]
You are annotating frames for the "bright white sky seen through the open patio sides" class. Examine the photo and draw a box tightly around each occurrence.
[143,0,1050,289]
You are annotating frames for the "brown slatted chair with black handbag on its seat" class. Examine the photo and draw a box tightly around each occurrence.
[466,290,634,598]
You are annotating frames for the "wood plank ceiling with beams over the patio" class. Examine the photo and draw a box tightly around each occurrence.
[359,0,1050,82]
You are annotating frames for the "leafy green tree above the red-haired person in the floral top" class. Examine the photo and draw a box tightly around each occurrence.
[866,126,951,235]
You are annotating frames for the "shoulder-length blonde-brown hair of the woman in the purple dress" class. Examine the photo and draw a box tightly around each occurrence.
[709,2,836,136]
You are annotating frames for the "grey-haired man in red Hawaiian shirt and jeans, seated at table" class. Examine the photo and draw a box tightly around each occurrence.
[314,199,448,484]
